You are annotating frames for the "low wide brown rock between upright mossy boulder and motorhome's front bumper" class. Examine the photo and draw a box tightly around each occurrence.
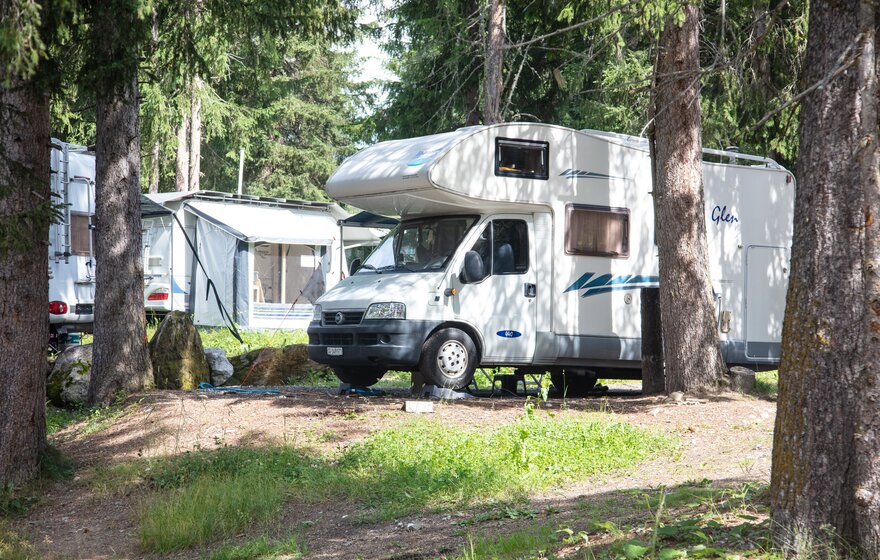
[225,344,329,386]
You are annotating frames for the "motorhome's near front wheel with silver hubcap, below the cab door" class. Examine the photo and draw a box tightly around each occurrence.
[419,328,480,389]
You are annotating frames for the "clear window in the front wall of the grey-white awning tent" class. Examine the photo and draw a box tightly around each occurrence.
[253,243,324,304]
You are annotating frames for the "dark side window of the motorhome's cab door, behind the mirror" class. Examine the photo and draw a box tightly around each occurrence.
[471,220,529,281]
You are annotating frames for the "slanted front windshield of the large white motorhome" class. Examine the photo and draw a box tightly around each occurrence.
[357,216,477,274]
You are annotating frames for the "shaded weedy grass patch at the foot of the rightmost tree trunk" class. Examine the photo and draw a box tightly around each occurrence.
[451,483,782,560]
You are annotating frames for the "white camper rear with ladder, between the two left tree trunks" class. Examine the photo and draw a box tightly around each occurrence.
[49,138,95,347]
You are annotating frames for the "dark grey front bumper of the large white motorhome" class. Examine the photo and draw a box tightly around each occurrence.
[308,319,440,370]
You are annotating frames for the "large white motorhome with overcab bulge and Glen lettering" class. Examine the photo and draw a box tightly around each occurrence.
[308,123,795,389]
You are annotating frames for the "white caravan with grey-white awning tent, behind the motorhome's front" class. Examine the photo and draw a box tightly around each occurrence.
[141,191,380,329]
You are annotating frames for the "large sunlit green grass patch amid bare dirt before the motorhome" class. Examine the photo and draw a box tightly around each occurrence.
[88,408,675,553]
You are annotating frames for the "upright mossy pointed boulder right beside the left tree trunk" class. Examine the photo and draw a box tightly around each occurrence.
[150,311,211,390]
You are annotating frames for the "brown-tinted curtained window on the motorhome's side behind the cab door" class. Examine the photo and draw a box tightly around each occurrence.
[565,204,629,258]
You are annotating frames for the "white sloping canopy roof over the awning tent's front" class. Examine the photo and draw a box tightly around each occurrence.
[185,200,339,245]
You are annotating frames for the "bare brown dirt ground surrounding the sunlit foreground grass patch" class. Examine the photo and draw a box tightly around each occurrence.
[12,388,776,559]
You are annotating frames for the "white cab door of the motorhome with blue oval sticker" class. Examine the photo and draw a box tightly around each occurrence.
[454,216,546,363]
